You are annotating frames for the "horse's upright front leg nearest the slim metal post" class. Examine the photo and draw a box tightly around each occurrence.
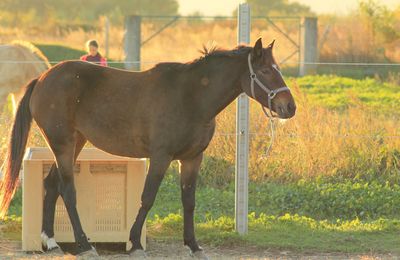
[180,154,207,259]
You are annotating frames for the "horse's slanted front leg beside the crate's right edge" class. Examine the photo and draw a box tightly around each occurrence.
[129,153,172,257]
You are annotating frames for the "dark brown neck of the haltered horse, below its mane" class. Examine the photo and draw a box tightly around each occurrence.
[201,57,245,120]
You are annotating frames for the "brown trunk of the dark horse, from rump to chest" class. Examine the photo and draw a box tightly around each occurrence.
[30,61,213,157]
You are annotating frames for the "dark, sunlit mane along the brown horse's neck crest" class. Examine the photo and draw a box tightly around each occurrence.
[154,45,252,71]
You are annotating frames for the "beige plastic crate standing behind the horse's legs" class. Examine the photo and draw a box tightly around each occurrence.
[22,148,146,251]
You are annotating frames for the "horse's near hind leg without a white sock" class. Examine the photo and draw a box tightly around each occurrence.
[45,131,92,255]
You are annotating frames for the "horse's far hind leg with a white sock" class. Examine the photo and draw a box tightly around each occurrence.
[41,135,86,252]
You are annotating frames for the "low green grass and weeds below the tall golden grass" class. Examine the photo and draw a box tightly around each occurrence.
[148,172,400,255]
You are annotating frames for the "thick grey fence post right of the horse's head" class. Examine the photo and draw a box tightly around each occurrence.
[300,17,318,76]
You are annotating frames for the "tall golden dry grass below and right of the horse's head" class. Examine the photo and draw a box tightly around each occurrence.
[208,83,400,181]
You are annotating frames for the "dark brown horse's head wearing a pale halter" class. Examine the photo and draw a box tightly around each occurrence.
[241,38,296,118]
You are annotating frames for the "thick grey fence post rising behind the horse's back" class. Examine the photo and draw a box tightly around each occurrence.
[124,15,142,71]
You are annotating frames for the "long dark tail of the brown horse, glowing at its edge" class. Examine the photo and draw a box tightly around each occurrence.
[0,79,38,218]
